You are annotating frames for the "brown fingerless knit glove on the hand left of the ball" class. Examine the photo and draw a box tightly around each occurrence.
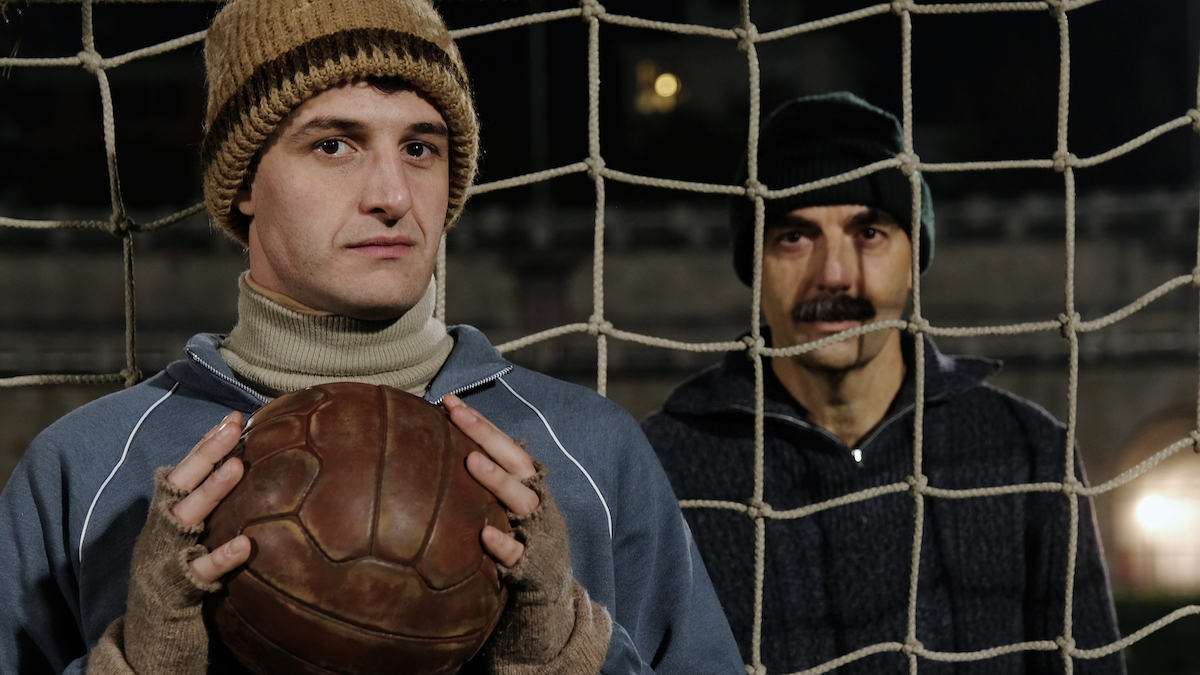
[88,466,221,675]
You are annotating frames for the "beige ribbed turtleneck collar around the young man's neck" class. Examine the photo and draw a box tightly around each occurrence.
[221,273,454,396]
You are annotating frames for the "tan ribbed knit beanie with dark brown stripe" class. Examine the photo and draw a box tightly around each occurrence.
[200,0,479,245]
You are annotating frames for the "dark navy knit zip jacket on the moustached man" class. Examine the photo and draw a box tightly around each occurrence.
[642,334,1124,674]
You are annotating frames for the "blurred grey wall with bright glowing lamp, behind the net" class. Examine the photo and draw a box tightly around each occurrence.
[0,191,1200,591]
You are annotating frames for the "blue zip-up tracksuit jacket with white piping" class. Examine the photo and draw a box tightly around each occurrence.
[0,325,744,675]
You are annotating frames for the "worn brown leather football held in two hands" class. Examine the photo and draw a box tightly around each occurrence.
[206,382,509,675]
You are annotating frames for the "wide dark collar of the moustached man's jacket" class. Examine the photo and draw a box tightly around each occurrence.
[662,328,1002,416]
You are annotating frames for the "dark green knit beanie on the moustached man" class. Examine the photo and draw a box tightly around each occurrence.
[730,91,934,286]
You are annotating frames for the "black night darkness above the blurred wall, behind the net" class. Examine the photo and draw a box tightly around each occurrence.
[0,0,1200,218]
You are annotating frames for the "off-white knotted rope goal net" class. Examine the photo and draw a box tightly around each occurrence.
[0,0,1200,675]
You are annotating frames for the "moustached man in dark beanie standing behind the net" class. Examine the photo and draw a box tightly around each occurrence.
[643,92,1123,674]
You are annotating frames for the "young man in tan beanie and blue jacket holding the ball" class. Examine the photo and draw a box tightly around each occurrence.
[0,0,743,675]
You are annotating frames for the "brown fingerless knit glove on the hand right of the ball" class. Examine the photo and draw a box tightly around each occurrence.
[485,460,612,675]
